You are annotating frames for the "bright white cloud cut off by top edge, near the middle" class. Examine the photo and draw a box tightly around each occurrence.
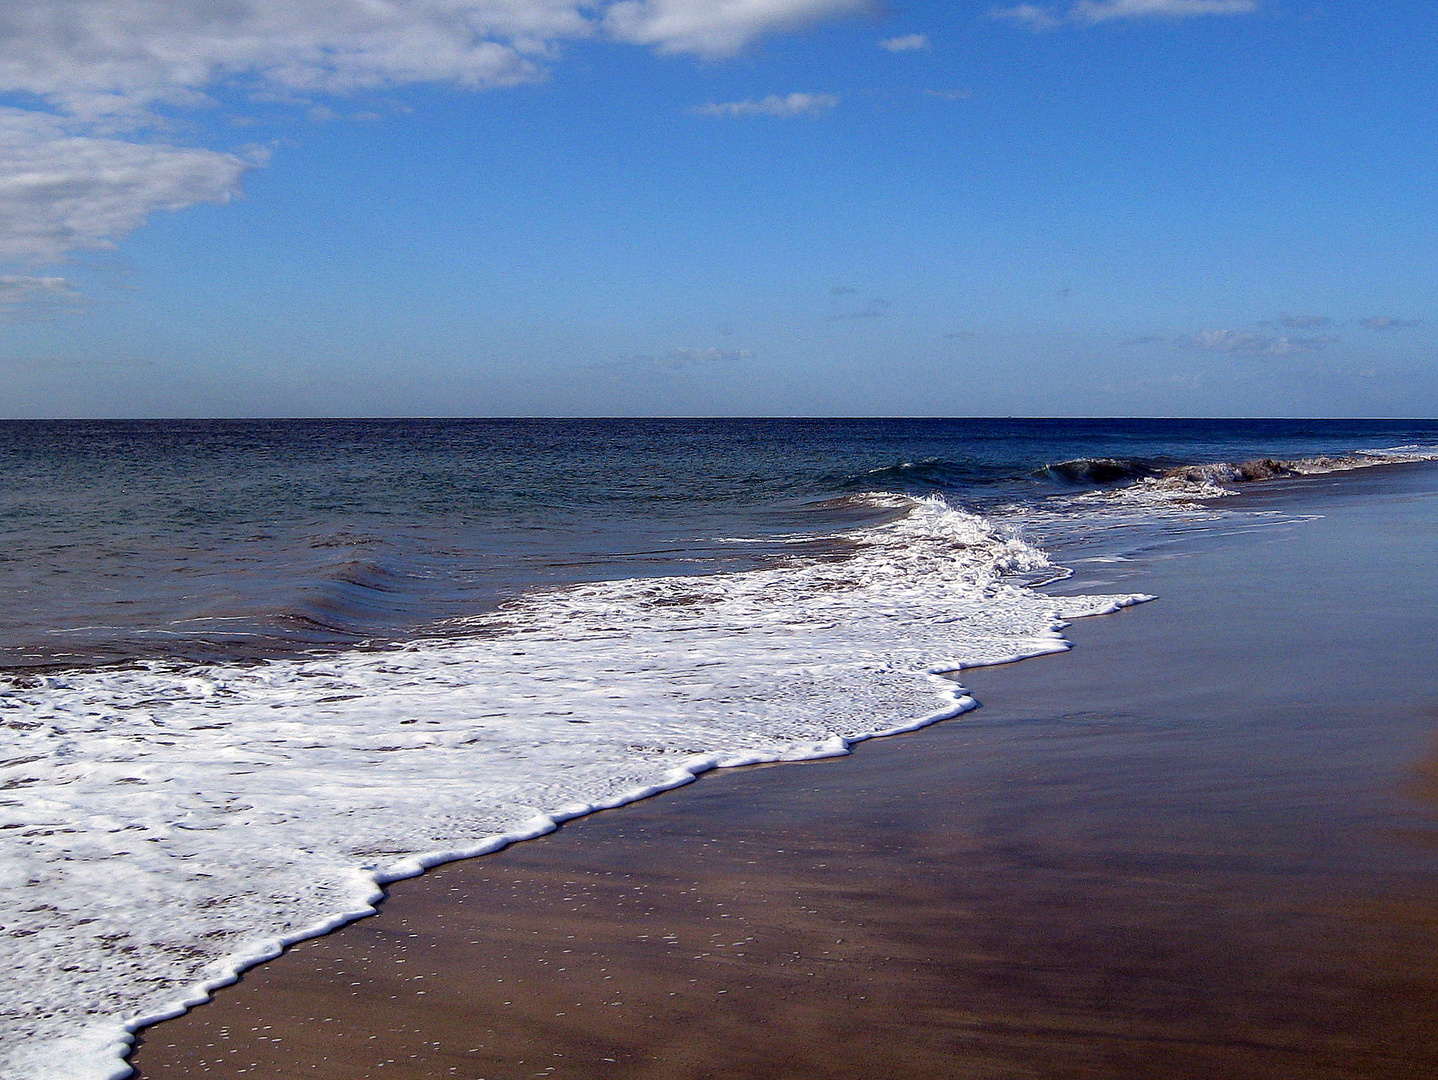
[603,0,870,58]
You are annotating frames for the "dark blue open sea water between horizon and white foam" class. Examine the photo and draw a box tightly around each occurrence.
[0,420,1438,669]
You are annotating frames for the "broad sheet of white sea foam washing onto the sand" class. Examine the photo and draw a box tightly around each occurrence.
[0,496,1145,1080]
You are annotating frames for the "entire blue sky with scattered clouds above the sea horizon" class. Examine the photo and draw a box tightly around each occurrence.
[0,0,1438,417]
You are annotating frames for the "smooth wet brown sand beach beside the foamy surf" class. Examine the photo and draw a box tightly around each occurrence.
[134,467,1438,1080]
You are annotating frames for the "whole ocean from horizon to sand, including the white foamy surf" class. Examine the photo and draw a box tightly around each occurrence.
[0,420,1438,1080]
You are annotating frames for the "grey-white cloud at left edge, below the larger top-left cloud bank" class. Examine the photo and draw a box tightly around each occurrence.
[0,109,253,264]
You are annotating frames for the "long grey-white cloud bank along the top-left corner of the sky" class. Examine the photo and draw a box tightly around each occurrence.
[0,0,592,116]
